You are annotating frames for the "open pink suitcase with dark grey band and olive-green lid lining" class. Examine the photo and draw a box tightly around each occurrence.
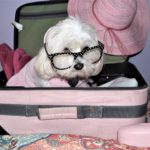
[0,0,148,139]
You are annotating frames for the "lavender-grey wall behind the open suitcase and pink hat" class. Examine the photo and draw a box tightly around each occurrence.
[0,0,150,85]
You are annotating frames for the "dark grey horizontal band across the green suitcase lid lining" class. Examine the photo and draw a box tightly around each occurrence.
[20,11,67,19]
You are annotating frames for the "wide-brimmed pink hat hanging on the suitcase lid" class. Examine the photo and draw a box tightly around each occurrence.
[68,0,149,55]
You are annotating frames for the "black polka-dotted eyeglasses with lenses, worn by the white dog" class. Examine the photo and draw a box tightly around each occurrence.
[44,41,104,70]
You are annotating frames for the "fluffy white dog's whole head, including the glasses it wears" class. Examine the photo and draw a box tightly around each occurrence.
[36,18,103,81]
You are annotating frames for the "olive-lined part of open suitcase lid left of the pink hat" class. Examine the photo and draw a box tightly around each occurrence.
[14,0,68,56]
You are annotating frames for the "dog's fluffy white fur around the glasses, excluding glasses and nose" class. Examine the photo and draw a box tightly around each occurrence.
[35,17,103,86]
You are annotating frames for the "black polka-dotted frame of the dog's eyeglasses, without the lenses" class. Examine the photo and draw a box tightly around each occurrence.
[44,41,104,70]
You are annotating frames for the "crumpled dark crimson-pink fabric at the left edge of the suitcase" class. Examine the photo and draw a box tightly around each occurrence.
[0,43,31,79]
